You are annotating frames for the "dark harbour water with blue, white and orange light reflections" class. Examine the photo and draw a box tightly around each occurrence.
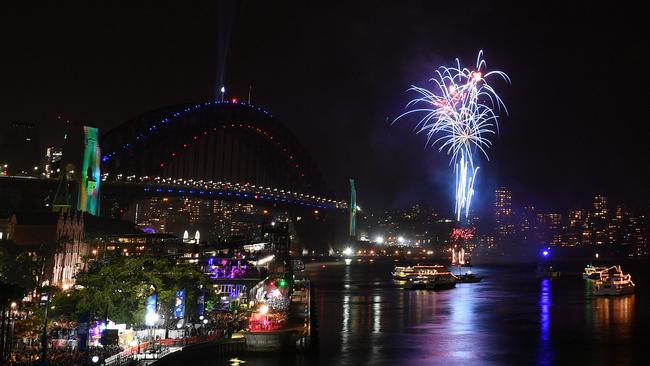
[205,261,650,366]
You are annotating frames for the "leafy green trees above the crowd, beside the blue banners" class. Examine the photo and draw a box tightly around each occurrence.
[53,254,207,325]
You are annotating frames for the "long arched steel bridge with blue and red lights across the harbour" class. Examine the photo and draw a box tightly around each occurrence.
[0,101,348,249]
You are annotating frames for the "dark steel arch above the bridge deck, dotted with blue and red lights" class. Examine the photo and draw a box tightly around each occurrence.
[101,102,329,195]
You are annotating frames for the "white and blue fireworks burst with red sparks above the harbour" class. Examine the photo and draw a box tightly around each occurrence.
[395,51,510,221]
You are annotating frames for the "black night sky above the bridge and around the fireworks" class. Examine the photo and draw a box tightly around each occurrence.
[0,1,650,216]
